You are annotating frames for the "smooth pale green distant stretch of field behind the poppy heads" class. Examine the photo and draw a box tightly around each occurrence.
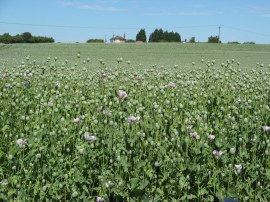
[0,43,270,69]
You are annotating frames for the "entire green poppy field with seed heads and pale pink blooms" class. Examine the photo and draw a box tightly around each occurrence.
[0,43,270,202]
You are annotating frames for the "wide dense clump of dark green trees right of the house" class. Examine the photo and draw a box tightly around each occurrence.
[149,29,181,42]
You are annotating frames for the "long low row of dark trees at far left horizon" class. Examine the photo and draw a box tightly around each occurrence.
[0,32,54,44]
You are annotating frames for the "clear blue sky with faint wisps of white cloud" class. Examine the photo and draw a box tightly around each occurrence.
[0,0,270,44]
